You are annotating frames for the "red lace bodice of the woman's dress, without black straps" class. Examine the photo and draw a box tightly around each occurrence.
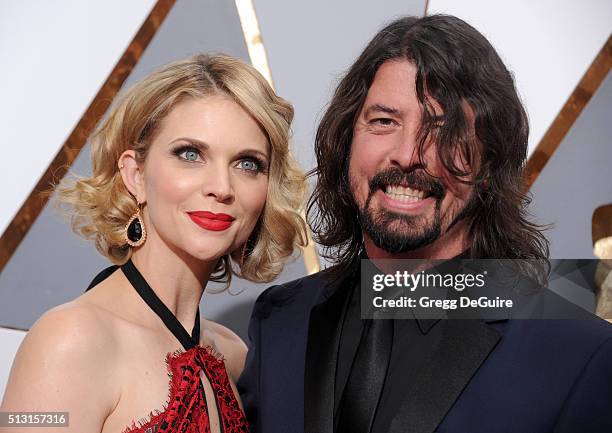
[123,346,249,433]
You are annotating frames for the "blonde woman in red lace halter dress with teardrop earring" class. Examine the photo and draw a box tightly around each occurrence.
[2,55,305,433]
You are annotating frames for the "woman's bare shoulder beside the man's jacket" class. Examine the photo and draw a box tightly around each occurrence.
[202,319,248,382]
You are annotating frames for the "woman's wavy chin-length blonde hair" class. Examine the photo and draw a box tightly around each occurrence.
[58,54,307,284]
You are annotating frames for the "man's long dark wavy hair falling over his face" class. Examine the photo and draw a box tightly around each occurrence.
[307,15,548,271]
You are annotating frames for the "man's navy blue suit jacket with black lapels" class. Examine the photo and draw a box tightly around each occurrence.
[238,272,612,433]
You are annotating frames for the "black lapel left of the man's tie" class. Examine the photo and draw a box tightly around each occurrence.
[304,272,353,433]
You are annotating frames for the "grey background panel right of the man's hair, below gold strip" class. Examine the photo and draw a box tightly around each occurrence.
[530,73,612,259]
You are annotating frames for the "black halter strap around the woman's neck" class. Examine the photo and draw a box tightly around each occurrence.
[121,259,200,350]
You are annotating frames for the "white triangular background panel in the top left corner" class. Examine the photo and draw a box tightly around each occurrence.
[0,0,156,233]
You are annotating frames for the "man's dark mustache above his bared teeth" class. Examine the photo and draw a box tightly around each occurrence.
[370,168,446,199]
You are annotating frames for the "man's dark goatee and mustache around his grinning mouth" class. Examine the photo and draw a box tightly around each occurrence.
[358,168,473,254]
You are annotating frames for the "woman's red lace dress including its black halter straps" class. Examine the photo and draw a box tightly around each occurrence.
[88,260,249,433]
